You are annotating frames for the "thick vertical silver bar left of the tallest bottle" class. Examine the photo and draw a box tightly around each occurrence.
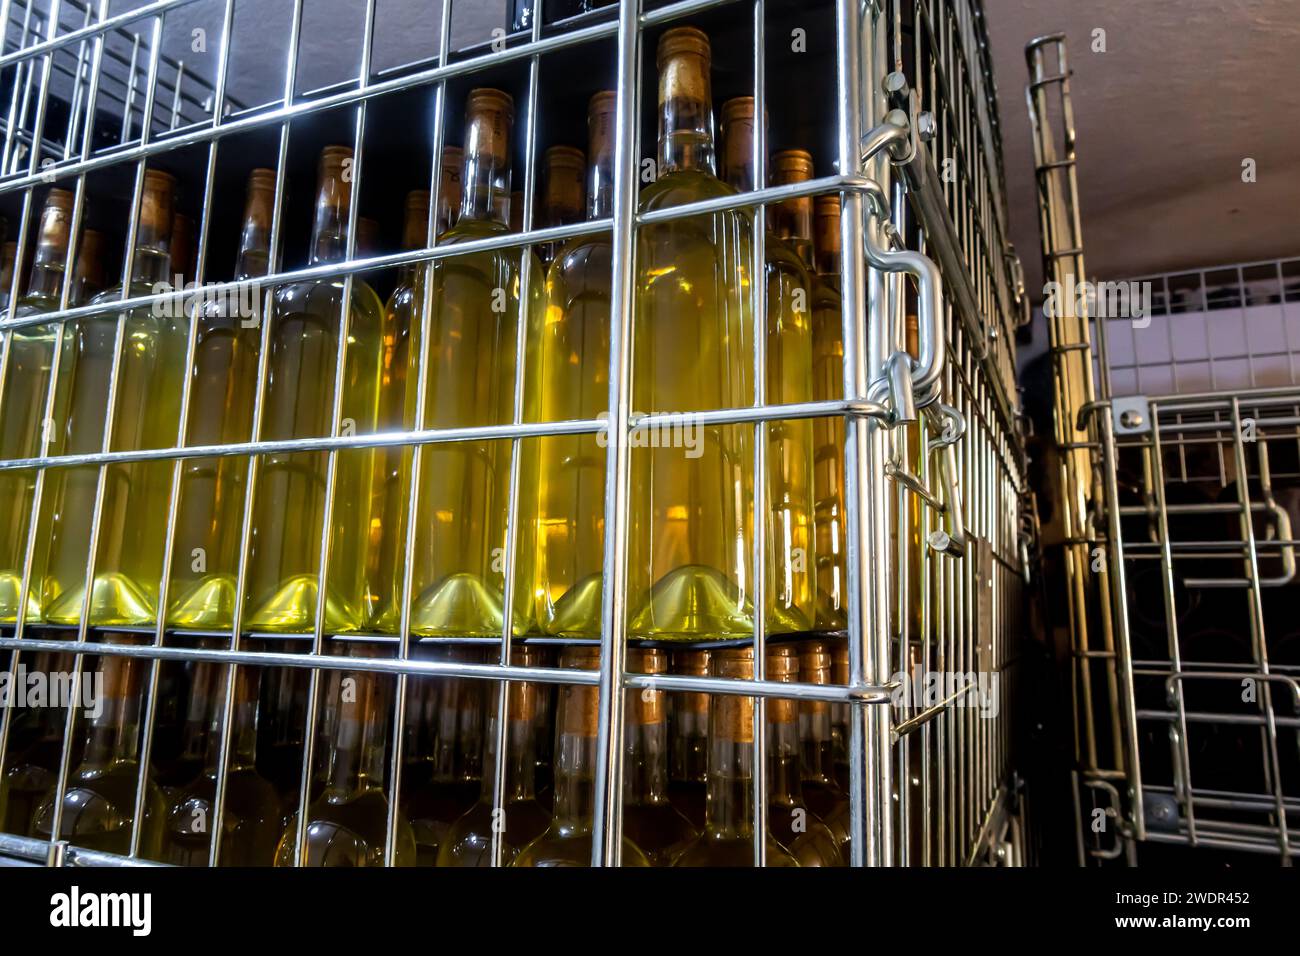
[592,0,641,866]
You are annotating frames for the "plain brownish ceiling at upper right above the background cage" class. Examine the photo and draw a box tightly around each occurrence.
[985,0,1300,293]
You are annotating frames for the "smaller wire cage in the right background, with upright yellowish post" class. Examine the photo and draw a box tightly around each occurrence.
[1027,35,1300,864]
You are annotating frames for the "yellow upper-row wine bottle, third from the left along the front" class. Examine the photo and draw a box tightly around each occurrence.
[168,169,276,631]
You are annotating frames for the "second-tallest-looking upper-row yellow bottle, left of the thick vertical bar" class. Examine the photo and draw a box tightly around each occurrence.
[411,88,543,636]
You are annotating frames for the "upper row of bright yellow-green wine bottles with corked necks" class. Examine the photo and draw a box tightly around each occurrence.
[0,27,845,640]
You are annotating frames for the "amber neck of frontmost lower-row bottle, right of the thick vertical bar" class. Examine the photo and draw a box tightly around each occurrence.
[705,695,754,839]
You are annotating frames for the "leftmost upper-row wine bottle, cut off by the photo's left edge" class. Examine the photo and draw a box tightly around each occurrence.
[0,189,77,623]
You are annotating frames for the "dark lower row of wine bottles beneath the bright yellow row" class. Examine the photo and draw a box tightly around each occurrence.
[0,636,849,866]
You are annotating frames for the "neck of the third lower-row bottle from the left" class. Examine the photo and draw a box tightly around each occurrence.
[325,672,387,799]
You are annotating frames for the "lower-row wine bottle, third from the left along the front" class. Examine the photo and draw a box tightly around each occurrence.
[276,644,416,866]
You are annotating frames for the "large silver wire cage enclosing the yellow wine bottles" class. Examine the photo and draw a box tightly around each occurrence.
[0,0,1032,865]
